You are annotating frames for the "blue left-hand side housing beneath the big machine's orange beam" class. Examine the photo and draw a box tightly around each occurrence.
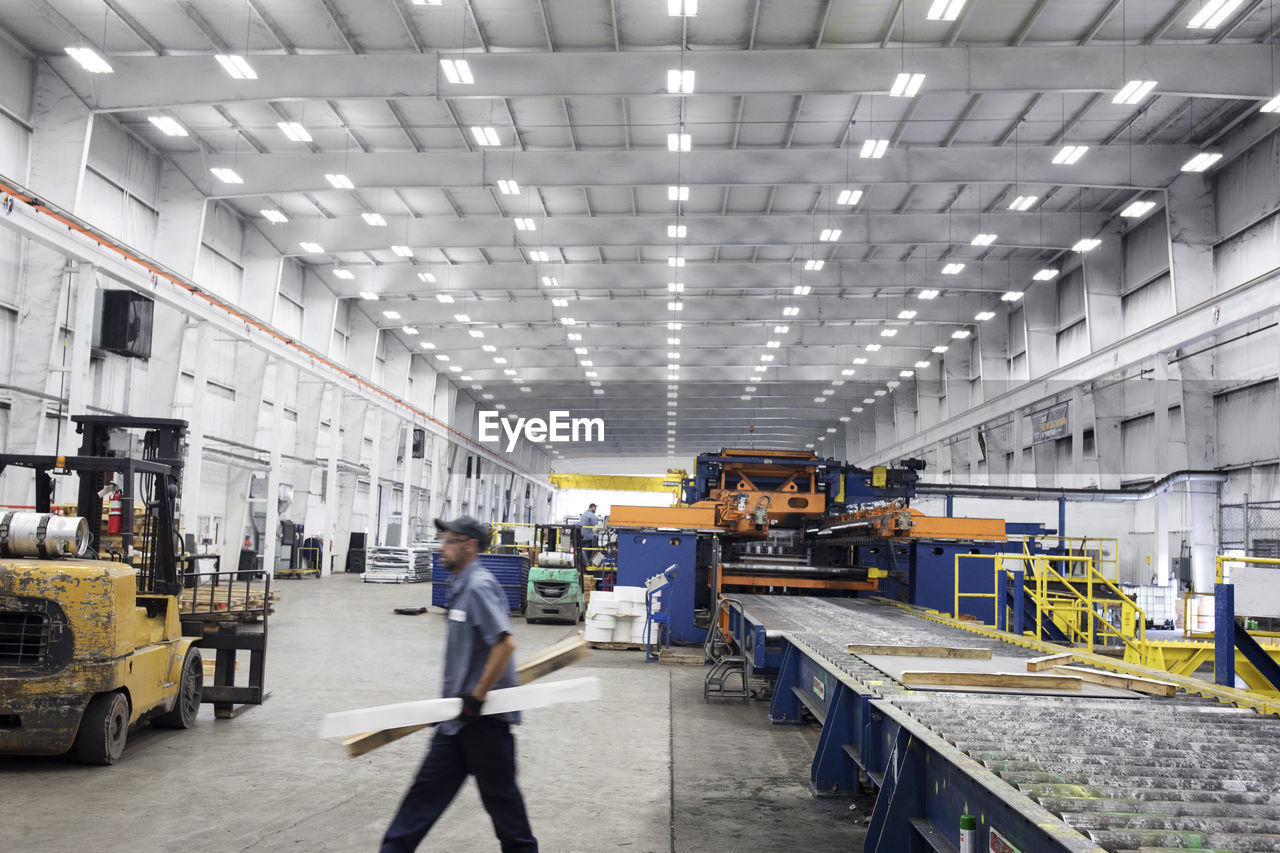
[618,530,709,643]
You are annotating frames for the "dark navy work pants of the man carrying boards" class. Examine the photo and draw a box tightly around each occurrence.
[381,717,538,853]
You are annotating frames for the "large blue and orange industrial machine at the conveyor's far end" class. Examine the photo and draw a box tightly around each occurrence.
[609,448,1043,643]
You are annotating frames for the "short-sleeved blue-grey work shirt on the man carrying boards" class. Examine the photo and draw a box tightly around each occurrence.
[440,560,520,734]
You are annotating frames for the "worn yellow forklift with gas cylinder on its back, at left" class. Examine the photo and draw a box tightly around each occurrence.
[0,416,265,765]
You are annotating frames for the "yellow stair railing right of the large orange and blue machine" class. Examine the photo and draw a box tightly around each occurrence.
[952,543,1152,661]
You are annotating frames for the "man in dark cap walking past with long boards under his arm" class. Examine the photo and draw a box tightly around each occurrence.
[381,516,538,853]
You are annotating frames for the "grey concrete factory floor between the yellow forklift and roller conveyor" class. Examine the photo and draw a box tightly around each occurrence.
[0,575,873,853]
